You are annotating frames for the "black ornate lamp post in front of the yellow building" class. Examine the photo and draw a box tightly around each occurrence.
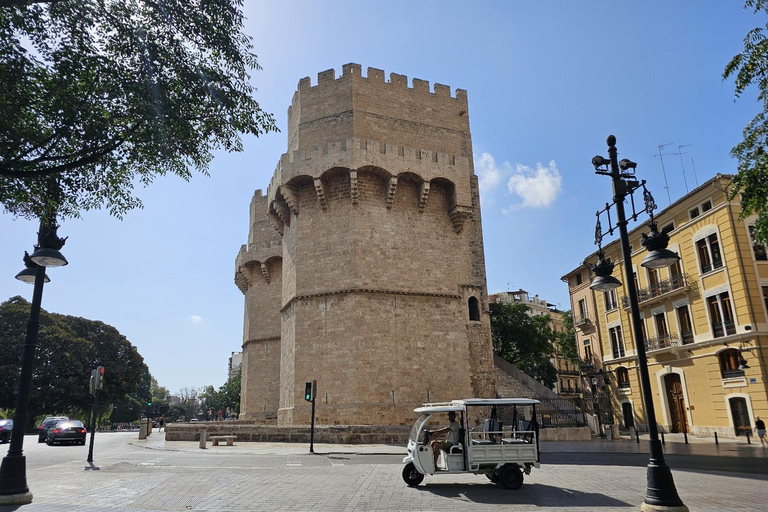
[590,135,688,512]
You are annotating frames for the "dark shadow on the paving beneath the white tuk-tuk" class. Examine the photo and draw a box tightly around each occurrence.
[416,483,637,509]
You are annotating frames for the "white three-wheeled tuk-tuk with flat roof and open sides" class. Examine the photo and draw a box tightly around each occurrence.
[403,398,540,489]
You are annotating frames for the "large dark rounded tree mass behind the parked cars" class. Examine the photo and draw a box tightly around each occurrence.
[0,296,145,426]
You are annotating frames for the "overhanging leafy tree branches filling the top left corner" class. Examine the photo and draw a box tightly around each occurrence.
[0,0,277,218]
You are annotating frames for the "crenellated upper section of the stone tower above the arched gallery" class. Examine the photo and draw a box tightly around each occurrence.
[288,63,472,157]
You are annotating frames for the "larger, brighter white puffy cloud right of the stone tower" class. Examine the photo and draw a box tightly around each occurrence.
[505,160,563,209]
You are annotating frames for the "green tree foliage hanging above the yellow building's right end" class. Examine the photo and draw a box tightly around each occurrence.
[723,0,768,244]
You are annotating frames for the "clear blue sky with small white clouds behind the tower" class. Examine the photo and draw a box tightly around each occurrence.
[0,0,765,393]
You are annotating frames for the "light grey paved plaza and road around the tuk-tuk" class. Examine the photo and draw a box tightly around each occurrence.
[0,432,768,512]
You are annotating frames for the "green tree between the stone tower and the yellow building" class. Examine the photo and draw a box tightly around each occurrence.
[490,303,557,388]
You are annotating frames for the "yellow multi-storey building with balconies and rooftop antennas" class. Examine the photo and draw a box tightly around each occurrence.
[564,174,768,437]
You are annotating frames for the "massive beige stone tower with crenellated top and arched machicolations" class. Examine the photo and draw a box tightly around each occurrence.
[235,64,495,425]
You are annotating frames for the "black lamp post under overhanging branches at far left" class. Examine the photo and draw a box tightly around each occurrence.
[0,218,67,505]
